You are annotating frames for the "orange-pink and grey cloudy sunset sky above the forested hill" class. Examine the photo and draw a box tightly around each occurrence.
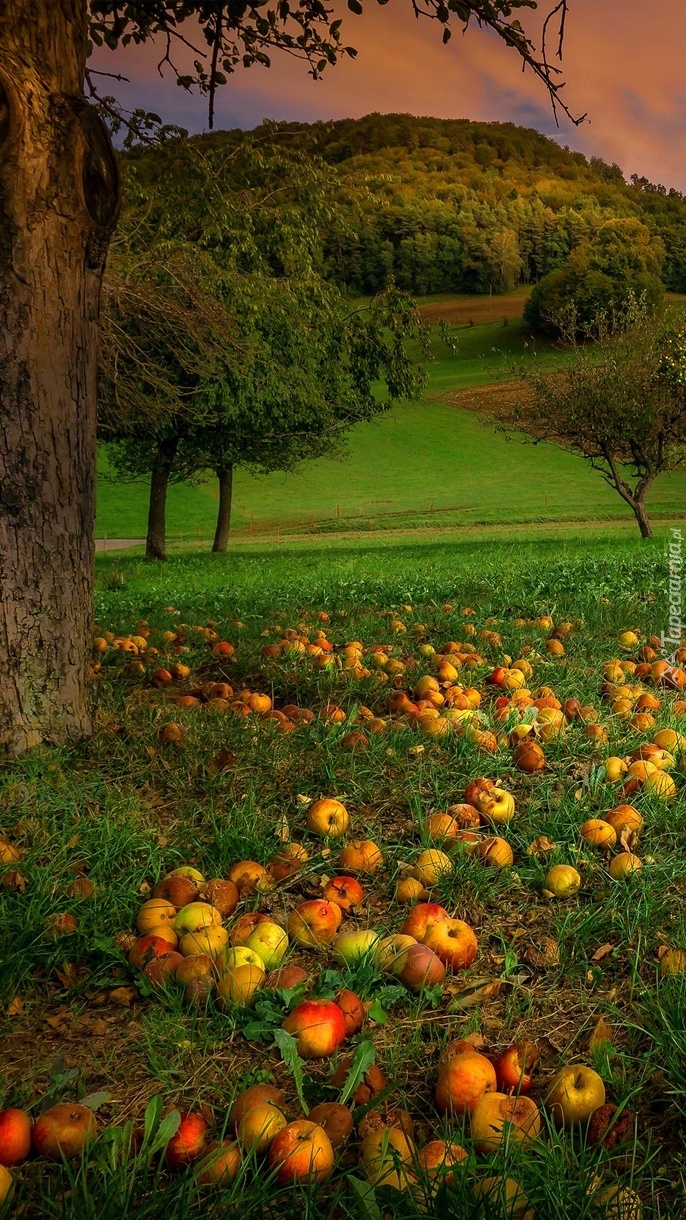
[92,0,686,192]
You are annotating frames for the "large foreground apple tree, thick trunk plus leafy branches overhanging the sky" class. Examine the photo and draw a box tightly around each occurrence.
[0,0,576,753]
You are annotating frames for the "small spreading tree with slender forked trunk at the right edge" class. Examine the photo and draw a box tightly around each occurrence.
[490,303,686,538]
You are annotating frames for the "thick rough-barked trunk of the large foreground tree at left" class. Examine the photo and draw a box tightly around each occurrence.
[0,0,118,753]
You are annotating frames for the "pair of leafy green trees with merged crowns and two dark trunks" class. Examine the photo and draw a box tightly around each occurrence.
[100,141,425,559]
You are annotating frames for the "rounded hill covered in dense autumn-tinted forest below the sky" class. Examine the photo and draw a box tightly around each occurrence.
[190,113,686,294]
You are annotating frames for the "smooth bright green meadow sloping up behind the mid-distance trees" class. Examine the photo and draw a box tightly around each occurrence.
[98,293,686,542]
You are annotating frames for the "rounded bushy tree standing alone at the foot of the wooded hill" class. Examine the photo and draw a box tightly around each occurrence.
[524,218,664,336]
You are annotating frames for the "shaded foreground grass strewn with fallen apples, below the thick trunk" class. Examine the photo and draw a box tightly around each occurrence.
[0,532,686,1220]
